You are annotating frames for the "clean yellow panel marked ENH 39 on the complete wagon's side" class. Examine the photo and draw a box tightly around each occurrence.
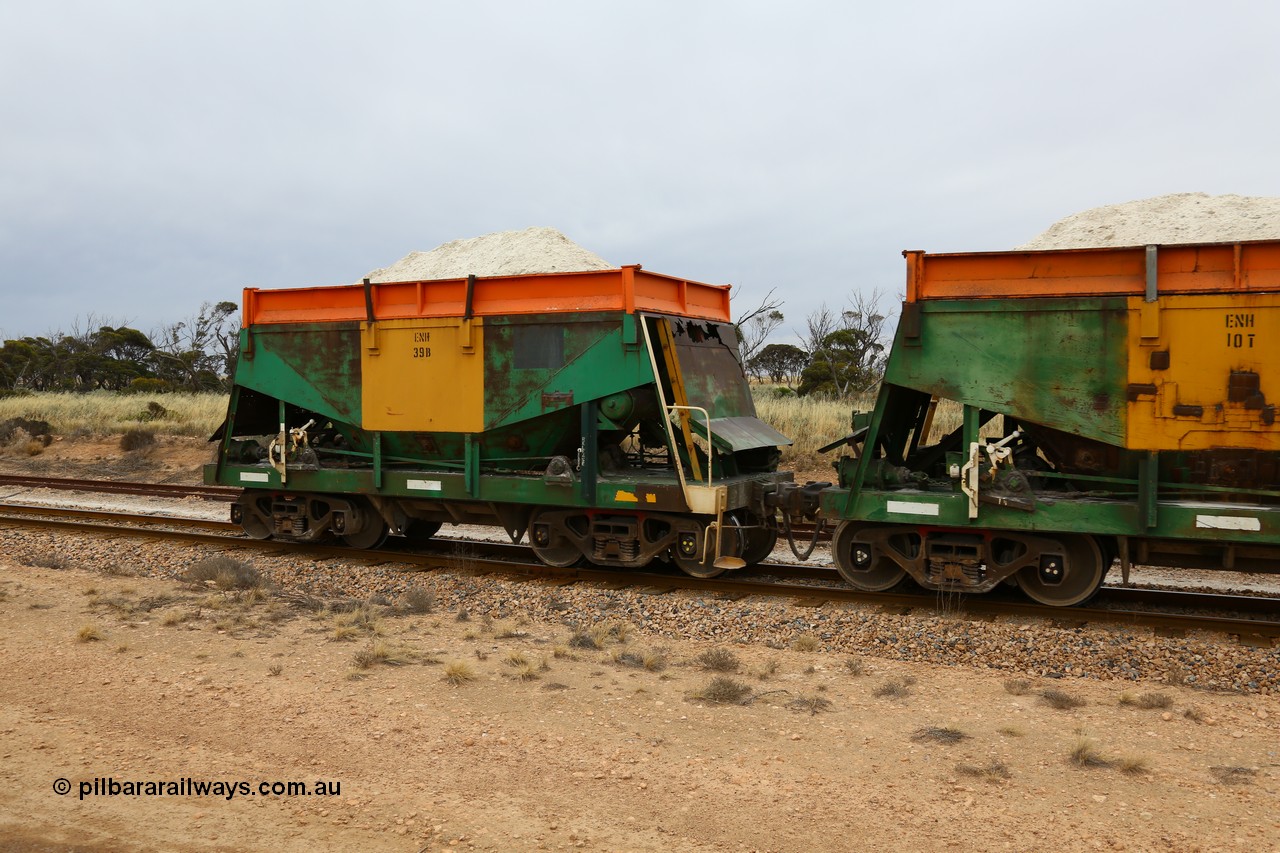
[360,318,484,433]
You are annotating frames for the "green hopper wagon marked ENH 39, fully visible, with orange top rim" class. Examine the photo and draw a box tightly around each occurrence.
[205,265,790,576]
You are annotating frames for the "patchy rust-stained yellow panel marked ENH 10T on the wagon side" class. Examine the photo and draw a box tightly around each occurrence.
[1125,293,1280,451]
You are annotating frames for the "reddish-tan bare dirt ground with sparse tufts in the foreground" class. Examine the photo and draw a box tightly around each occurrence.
[0,435,1280,853]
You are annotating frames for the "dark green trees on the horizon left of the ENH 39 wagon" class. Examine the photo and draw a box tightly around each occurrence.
[0,302,239,392]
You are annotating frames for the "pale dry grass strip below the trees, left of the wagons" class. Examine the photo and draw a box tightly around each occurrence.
[0,391,227,438]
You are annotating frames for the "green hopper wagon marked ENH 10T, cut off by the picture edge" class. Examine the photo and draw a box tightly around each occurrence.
[820,242,1280,606]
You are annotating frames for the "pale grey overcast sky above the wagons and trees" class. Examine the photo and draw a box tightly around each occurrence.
[0,0,1280,338]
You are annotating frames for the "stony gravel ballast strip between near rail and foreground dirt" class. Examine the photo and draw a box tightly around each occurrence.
[0,497,1280,694]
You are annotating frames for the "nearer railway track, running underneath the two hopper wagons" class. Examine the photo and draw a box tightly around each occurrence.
[0,503,1280,637]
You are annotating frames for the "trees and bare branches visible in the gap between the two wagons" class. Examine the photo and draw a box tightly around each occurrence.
[735,291,888,400]
